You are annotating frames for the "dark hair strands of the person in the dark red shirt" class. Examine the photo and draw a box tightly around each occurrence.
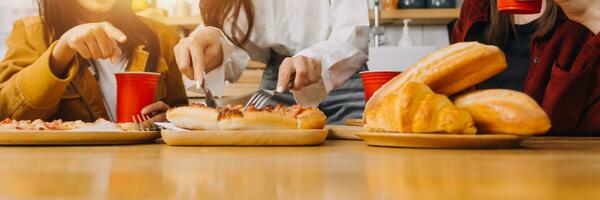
[484,0,562,48]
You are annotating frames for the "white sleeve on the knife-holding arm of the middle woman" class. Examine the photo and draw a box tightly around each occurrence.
[183,25,250,97]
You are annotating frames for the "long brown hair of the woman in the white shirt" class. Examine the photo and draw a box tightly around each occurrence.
[200,0,254,47]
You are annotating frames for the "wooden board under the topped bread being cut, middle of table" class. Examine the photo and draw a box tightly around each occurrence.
[161,129,328,146]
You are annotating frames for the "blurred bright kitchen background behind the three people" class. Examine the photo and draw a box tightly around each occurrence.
[0,0,462,100]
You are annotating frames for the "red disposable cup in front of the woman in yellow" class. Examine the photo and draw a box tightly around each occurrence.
[115,72,160,123]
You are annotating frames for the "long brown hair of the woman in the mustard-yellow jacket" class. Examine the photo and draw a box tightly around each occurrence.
[37,0,161,71]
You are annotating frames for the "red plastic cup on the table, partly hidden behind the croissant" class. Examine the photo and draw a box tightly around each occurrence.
[360,71,401,102]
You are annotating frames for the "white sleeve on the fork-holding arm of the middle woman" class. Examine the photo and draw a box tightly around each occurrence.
[292,0,369,106]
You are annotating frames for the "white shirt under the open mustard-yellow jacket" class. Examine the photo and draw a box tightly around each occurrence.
[90,59,127,122]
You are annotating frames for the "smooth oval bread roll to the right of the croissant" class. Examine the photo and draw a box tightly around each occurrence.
[454,89,551,135]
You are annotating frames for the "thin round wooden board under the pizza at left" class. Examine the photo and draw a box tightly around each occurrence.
[0,131,160,145]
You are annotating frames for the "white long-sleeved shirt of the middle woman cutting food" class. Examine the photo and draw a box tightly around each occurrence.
[185,0,369,106]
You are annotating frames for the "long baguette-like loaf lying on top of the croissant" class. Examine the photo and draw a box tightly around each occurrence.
[367,42,506,106]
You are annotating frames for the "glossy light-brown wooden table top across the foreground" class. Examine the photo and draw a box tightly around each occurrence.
[0,138,600,199]
